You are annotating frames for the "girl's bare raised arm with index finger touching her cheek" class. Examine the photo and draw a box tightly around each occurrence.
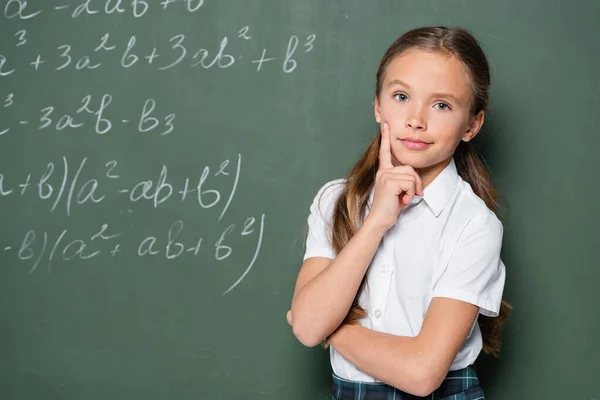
[291,124,423,347]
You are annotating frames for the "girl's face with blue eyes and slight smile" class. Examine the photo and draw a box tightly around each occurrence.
[375,49,484,185]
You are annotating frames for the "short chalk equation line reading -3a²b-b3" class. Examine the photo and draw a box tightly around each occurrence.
[0,93,176,136]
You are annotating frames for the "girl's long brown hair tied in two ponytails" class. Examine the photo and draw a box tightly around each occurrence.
[324,27,512,357]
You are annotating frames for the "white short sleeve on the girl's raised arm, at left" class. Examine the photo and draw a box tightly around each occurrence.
[304,179,343,260]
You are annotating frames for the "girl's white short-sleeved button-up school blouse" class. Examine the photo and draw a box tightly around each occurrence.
[304,160,506,382]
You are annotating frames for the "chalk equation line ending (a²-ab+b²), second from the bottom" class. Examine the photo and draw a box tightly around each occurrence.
[0,154,242,217]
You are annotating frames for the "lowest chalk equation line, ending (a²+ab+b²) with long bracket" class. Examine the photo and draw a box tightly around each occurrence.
[5,214,265,294]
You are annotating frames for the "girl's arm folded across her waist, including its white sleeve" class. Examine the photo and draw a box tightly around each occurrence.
[331,212,506,396]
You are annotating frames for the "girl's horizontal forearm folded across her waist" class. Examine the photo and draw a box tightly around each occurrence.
[330,325,435,396]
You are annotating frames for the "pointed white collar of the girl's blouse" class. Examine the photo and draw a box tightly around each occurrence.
[368,158,460,217]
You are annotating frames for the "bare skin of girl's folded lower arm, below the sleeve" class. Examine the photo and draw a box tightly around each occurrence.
[331,297,479,396]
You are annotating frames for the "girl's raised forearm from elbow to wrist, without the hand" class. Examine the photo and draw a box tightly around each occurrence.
[292,219,386,345]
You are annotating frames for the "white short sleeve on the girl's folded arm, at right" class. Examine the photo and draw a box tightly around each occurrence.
[432,211,506,317]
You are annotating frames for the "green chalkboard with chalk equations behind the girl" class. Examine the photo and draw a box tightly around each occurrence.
[0,0,600,400]
